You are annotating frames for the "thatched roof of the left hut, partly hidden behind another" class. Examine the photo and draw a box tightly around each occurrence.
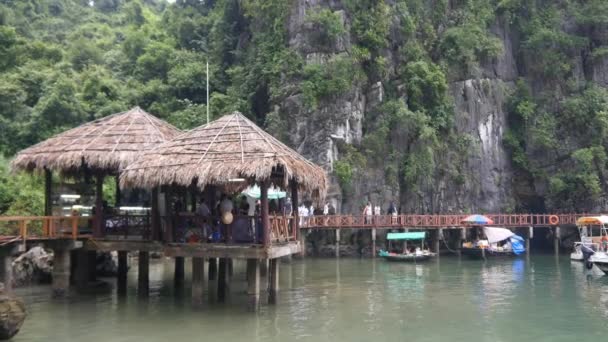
[11,107,181,174]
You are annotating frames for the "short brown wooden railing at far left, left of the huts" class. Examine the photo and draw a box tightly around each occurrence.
[0,216,93,241]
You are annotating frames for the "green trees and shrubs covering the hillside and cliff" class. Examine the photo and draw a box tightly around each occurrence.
[0,0,608,213]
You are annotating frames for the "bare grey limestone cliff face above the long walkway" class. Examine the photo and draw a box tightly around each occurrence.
[273,0,608,213]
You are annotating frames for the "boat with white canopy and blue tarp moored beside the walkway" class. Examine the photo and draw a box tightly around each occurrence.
[460,227,526,259]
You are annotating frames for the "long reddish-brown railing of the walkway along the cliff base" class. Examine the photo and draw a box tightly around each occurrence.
[300,214,588,229]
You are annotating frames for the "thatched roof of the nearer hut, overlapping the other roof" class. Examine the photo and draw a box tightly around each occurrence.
[120,112,327,196]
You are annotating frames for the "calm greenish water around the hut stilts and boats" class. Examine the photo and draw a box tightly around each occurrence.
[14,256,608,342]
